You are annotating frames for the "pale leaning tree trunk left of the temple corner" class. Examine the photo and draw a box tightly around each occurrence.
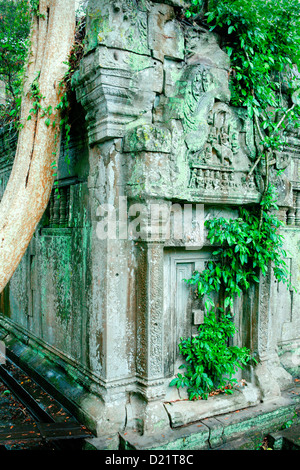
[0,0,75,292]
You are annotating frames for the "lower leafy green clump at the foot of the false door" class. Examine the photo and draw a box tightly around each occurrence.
[170,309,251,400]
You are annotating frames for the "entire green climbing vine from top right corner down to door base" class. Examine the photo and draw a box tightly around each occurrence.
[170,0,300,399]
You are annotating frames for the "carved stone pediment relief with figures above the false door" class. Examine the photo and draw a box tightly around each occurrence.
[170,65,264,202]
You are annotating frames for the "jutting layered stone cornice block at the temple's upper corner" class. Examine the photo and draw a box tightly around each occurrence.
[74,47,163,144]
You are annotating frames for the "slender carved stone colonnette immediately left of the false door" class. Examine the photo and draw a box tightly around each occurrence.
[136,227,169,433]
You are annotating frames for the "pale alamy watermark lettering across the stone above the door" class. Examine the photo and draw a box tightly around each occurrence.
[96,196,204,248]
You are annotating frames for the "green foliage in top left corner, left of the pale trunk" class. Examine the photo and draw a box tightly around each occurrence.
[0,0,31,124]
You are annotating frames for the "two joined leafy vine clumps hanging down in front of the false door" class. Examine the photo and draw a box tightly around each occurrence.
[170,186,282,399]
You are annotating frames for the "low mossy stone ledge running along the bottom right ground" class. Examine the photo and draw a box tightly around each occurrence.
[120,386,300,450]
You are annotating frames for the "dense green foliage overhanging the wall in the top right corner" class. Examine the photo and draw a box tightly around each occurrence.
[186,0,300,158]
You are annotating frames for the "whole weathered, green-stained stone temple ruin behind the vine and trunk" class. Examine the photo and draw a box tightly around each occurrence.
[0,0,300,449]
